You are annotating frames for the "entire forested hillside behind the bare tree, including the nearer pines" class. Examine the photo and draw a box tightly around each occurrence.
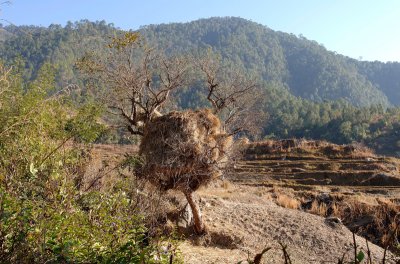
[0,17,400,154]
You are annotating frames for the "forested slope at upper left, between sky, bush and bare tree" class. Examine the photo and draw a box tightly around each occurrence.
[0,20,118,86]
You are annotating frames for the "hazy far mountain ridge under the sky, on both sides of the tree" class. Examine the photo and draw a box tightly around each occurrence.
[0,17,400,106]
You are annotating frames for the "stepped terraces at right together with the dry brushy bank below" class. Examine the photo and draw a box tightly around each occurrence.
[228,140,400,251]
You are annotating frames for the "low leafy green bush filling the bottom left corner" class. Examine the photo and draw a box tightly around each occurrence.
[0,187,181,263]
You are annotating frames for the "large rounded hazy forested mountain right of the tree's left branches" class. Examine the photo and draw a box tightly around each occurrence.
[141,17,394,105]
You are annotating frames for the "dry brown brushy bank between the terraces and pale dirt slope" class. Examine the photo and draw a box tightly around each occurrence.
[264,187,400,253]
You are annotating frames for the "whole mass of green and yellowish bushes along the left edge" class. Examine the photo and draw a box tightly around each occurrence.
[0,65,179,263]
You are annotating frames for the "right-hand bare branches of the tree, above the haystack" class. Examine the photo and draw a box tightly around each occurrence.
[193,50,265,138]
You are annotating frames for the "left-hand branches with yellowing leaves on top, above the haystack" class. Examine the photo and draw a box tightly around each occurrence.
[77,33,192,136]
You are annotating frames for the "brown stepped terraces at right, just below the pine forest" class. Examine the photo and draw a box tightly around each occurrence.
[229,141,400,194]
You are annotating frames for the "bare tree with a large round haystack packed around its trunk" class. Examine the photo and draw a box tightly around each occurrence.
[78,33,259,234]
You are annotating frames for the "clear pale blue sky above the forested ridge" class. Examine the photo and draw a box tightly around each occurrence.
[0,0,400,62]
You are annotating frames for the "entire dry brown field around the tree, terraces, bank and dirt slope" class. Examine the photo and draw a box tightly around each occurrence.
[87,143,400,263]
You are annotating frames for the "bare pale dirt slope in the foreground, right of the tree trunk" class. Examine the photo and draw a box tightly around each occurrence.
[181,187,394,263]
